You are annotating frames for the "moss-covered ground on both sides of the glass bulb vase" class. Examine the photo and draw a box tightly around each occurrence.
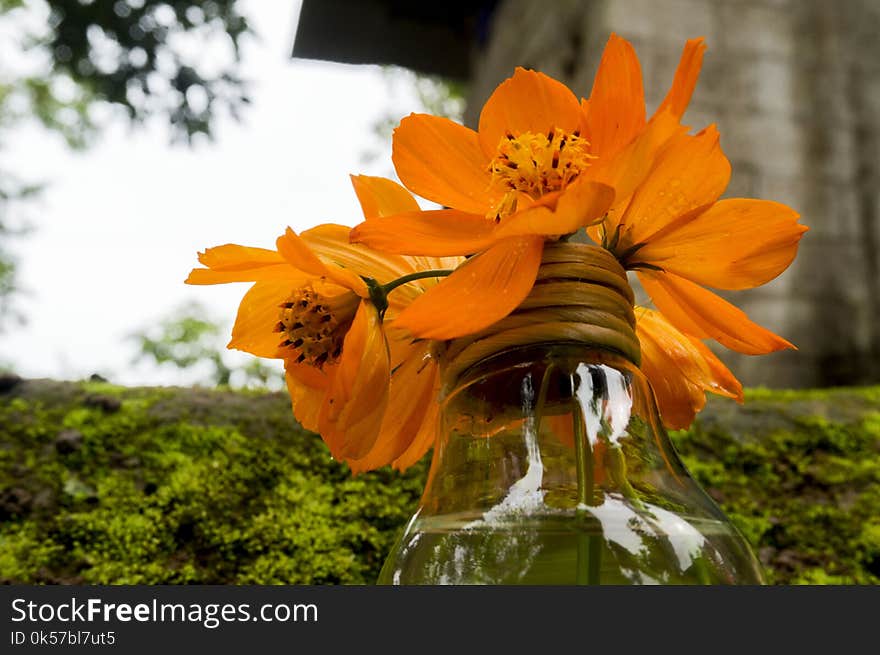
[0,380,880,584]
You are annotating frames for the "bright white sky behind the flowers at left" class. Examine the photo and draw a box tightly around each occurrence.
[0,0,416,385]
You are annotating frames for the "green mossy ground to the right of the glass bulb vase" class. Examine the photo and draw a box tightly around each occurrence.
[674,388,880,584]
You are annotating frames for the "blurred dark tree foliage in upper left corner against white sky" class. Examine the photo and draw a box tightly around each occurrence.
[0,0,250,328]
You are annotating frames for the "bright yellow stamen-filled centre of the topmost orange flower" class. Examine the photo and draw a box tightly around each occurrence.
[489,128,596,221]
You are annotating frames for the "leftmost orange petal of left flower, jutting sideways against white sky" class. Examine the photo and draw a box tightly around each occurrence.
[186,243,302,284]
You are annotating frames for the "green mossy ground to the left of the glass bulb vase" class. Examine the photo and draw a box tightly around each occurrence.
[0,382,424,584]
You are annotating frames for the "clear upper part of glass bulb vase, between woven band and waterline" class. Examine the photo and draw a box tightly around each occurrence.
[422,343,686,520]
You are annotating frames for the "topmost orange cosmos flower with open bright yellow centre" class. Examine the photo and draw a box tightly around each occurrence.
[352,35,704,339]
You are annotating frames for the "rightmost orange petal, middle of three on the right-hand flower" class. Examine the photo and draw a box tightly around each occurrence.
[630,198,808,289]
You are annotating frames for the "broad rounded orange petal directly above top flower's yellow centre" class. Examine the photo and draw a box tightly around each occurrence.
[474,68,581,157]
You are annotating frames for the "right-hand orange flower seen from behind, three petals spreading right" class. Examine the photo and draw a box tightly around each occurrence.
[600,126,808,355]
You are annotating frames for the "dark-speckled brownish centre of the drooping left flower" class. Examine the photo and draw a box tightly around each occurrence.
[275,288,360,368]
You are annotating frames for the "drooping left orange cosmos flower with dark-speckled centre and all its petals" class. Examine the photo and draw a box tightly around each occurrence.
[186,176,459,472]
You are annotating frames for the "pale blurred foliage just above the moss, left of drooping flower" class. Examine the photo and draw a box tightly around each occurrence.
[132,302,282,389]
